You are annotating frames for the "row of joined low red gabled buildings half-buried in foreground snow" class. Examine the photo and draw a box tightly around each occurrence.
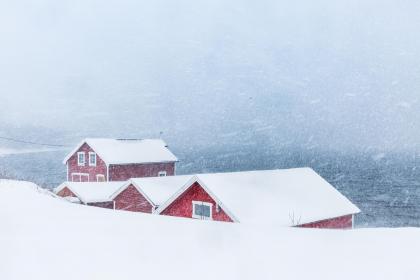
[56,168,360,229]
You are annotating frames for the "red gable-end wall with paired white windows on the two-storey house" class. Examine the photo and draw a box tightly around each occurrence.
[67,143,107,182]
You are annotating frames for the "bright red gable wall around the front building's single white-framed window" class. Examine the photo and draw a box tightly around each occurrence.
[161,182,233,222]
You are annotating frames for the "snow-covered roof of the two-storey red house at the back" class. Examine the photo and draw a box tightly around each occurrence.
[63,138,178,164]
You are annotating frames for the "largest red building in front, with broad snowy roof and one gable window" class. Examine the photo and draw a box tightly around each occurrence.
[156,168,360,229]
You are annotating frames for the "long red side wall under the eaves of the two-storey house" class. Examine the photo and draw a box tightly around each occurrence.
[109,162,175,181]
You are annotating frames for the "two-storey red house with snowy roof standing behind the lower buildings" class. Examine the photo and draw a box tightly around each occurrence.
[63,138,178,182]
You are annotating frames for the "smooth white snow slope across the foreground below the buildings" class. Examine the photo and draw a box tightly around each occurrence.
[0,181,420,280]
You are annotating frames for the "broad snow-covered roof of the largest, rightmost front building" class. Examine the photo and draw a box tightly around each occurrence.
[157,168,360,226]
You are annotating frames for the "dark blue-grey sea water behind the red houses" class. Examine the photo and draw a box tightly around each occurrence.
[0,148,420,227]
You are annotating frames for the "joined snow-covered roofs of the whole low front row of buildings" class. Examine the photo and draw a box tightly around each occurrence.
[56,168,360,226]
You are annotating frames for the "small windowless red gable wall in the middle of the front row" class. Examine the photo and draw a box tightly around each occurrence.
[114,185,153,213]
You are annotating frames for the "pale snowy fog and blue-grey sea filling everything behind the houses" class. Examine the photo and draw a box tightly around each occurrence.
[0,0,420,226]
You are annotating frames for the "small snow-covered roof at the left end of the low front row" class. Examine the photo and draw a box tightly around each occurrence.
[54,182,126,203]
